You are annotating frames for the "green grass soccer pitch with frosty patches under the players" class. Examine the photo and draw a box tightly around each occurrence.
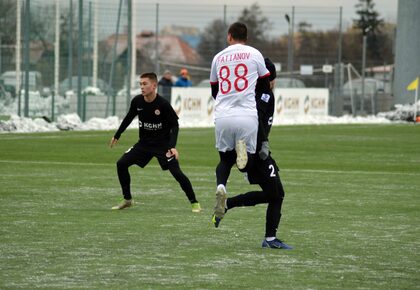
[0,124,420,289]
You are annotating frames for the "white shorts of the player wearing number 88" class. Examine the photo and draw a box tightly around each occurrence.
[214,116,258,154]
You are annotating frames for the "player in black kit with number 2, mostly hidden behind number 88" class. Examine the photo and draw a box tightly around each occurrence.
[212,58,293,250]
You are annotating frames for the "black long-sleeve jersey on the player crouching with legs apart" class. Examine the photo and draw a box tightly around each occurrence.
[114,95,179,150]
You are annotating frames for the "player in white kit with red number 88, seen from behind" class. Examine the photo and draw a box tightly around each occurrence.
[210,22,270,219]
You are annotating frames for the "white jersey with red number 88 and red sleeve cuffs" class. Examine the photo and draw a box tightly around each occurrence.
[210,44,270,119]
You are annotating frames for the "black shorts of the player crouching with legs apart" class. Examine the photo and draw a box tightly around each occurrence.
[121,143,179,170]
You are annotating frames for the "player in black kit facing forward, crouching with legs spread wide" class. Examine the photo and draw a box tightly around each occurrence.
[110,73,201,212]
